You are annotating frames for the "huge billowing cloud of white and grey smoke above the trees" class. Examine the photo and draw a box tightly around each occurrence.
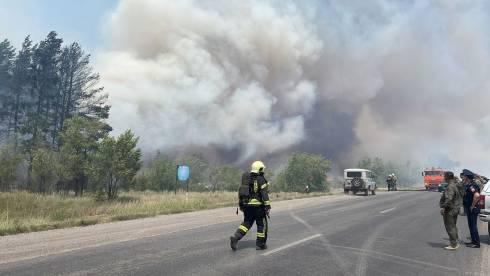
[98,0,490,170]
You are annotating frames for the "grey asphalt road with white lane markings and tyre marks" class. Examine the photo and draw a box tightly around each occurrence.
[0,191,490,275]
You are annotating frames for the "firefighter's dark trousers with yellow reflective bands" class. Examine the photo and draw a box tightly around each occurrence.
[235,206,268,246]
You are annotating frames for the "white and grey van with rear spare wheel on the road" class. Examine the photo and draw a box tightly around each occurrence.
[344,169,377,196]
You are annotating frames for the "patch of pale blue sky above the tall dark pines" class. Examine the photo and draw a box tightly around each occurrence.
[0,0,118,50]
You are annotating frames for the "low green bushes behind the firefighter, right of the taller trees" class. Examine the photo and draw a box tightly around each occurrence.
[136,153,330,192]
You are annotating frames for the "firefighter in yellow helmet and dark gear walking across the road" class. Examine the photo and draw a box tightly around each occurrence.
[230,161,271,250]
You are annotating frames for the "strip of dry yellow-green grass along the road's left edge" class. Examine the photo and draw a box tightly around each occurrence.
[0,192,333,236]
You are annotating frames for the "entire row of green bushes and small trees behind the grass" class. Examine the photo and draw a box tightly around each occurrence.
[0,137,330,195]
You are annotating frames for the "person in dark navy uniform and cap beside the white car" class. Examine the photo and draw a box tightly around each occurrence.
[462,169,480,248]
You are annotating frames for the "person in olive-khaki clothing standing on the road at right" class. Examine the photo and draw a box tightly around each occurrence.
[439,171,464,250]
